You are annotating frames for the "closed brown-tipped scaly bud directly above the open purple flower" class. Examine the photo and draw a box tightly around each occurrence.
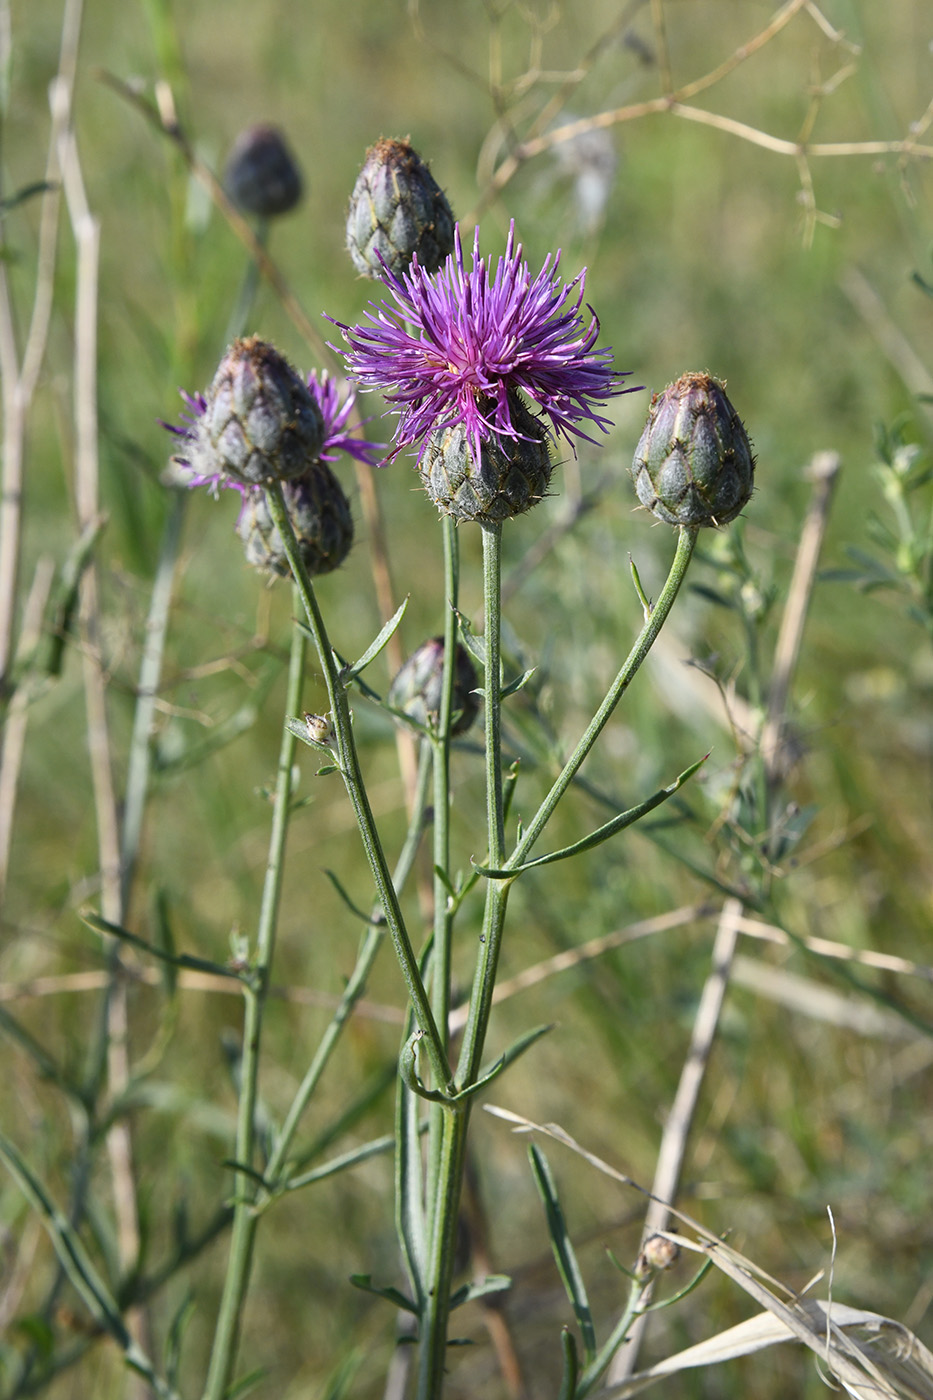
[346,140,454,279]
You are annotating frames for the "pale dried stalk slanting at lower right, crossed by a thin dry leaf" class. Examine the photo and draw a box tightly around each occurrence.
[607,899,741,1385]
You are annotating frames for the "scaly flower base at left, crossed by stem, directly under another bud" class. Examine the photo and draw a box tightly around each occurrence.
[237,462,353,578]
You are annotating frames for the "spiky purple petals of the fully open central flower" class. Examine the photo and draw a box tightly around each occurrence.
[335,224,630,462]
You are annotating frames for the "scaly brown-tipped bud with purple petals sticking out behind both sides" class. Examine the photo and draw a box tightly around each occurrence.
[185,336,324,486]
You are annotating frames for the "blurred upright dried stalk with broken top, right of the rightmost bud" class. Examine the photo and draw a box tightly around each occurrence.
[761,452,842,784]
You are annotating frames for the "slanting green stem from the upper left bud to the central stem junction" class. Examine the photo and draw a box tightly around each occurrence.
[266,484,452,1089]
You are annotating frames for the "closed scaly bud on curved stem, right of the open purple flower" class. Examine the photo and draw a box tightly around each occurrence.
[632,374,755,525]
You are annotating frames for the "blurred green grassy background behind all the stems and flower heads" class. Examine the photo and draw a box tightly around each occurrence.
[0,0,933,1400]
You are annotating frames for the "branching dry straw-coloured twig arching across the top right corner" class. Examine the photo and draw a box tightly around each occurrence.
[475,0,933,238]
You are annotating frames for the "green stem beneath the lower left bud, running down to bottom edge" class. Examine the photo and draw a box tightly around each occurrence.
[203,602,305,1400]
